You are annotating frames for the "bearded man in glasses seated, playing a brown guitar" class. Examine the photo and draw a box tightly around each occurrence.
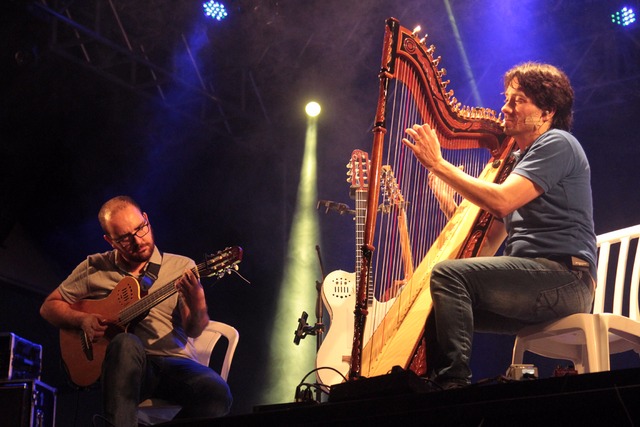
[40,196,232,427]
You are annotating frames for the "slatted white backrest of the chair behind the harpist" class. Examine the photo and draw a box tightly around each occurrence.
[593,225,640,321]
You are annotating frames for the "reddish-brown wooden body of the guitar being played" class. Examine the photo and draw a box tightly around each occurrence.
[60,277,140,387]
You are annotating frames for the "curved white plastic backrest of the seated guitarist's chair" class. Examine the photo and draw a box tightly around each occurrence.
[190,320,240,381]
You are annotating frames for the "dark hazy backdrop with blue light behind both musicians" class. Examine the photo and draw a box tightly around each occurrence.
[0,0,640,425]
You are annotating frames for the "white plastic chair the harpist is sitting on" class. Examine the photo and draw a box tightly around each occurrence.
[511,225,640,373]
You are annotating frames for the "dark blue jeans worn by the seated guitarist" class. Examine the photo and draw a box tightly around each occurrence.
[102,333,232,427]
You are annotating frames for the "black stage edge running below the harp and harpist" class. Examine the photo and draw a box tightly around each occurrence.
[163,369,640,427]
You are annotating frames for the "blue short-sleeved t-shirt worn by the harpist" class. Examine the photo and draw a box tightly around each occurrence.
[504,129,596,277]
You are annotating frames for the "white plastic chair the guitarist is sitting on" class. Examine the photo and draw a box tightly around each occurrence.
[138,320,240,426]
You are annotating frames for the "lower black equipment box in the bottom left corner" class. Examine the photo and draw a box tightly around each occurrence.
[0,380,56,427]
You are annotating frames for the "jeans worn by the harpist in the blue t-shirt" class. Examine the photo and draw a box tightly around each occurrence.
[425,256,594,384]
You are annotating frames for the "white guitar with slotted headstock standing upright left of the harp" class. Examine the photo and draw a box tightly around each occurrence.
[316,150,369,386]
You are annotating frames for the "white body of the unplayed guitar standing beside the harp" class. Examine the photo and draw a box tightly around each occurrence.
[316,270,356,385]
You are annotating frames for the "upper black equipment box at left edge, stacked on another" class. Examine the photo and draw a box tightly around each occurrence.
[0,332,42,380]
